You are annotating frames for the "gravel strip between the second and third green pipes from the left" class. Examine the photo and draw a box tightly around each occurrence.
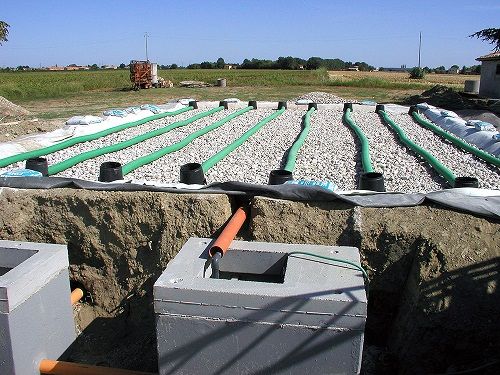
[57,110,233,179]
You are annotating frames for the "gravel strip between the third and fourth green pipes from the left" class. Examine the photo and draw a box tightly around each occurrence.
[127,109,274,183]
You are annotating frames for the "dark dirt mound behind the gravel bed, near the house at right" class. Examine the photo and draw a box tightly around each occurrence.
[405,85,474,110]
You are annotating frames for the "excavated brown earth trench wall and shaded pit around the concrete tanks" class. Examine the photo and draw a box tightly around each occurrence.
[0,189,500,374]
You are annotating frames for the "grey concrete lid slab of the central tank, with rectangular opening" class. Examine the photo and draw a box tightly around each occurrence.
[154,238,367,328]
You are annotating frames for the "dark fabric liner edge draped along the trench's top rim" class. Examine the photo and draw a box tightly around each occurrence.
[0,177,500,219]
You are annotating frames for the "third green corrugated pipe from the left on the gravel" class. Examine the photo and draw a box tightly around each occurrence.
[122,107,253,175]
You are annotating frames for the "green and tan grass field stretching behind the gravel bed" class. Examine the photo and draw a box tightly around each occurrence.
[0,69,477,118]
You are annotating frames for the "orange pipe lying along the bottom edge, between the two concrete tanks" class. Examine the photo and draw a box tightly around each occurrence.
[40,359,157,375]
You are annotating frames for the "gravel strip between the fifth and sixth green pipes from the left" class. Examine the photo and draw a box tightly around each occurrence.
[294,109,361,190]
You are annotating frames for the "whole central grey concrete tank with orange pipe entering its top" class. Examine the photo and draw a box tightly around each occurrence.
[154,238,367,374]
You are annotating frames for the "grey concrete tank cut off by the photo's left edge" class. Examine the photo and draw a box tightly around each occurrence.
[0,241,76,375]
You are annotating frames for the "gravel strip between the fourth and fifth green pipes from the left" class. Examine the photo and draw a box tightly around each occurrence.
[207,109,306,184]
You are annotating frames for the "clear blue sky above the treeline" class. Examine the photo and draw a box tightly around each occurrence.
[0,0,500,68]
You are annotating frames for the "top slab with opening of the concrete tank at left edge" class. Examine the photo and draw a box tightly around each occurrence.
[0,240,69,313]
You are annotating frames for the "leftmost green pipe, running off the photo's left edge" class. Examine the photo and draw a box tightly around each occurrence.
[0,107,193,167]
